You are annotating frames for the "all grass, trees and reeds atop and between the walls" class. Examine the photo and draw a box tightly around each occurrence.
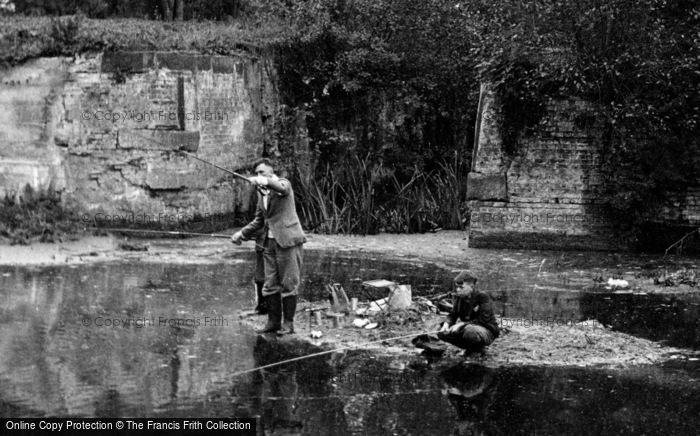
[0,0,700,245]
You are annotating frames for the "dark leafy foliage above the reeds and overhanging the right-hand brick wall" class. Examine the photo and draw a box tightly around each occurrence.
[271,0,700,238]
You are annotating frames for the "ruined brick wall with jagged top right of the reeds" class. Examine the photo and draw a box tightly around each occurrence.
[468,86,700,250]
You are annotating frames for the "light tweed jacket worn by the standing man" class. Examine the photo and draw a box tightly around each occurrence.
[241,178,306,248]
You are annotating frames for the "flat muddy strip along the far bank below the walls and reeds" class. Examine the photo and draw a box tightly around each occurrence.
[0,231,700,293]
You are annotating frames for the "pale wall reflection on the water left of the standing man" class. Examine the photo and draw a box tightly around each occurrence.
[0,264,253,416]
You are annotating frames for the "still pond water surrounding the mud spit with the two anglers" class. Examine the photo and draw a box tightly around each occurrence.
[0,251,700,435]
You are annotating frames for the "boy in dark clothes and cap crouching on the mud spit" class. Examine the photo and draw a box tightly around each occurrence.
[438,271,499,353]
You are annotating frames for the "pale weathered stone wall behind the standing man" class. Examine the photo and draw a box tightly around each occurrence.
[0,52,274,227]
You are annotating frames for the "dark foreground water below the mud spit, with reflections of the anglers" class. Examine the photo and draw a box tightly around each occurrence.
[230,353,700,435]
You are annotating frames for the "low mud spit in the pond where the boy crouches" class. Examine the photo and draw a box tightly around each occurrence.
[243,303,697,368]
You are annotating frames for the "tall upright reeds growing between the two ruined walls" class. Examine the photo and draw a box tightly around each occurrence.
[297,154,469,235]
